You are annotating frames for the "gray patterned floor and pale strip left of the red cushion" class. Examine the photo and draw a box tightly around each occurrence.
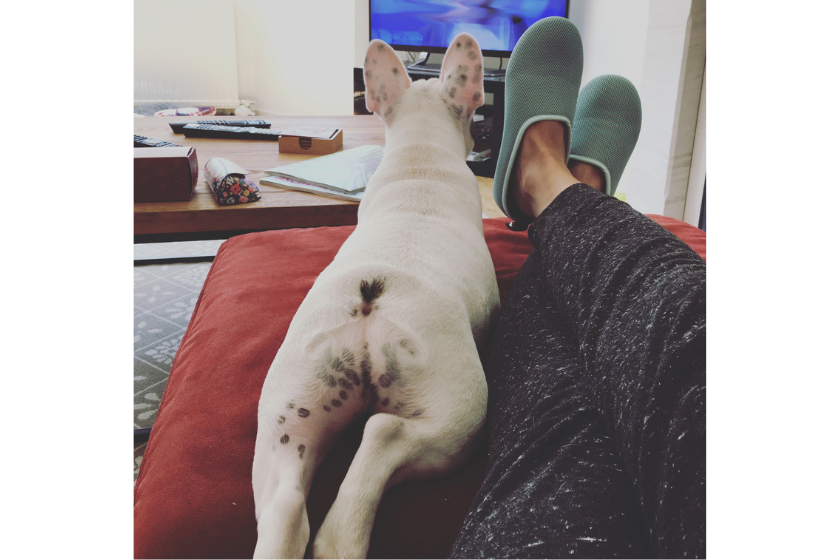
[134,240,223,481]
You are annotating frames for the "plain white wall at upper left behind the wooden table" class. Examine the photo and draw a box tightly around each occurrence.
[134,0,355,115]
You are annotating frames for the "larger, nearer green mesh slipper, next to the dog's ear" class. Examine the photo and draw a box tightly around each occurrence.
[493,17,583,230]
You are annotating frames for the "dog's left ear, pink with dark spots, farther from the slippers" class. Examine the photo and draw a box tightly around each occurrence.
[365,39,411,122]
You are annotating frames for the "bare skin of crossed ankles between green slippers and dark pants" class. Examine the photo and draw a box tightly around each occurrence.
[512,121,604,218]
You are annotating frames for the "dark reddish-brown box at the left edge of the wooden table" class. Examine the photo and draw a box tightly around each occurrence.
[134,146,198,202]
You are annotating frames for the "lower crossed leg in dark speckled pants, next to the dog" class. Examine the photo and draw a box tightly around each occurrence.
[451,252,653,558]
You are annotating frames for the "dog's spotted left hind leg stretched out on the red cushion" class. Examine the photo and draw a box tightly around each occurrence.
[252,330,365,558]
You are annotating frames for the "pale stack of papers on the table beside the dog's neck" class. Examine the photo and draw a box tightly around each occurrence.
[260,146,385,201]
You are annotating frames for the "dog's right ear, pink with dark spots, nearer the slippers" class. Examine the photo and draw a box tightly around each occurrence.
[440,33,484,120]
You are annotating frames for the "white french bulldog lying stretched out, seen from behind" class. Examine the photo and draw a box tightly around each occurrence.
[253,33,499,558]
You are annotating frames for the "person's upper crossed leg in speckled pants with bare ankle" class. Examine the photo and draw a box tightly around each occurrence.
[513,100,705,556]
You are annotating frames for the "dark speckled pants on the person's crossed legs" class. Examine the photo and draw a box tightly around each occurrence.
[452,184,706,558]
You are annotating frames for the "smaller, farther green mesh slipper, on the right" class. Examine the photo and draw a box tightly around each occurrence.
[569,74,642,196]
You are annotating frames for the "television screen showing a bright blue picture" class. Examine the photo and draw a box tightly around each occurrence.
[370,0,568,53]
